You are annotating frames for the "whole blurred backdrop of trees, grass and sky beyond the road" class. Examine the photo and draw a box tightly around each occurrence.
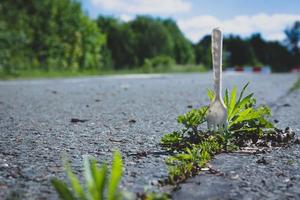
[0,0,300,79]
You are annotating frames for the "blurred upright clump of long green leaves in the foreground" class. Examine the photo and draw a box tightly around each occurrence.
[51,152,123,200]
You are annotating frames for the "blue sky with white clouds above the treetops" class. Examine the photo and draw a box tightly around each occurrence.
[82,0,300,43]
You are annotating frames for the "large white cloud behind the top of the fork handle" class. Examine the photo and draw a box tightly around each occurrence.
[178,14,300,42]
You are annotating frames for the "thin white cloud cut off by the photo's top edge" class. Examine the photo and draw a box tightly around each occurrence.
[91,0,191,15]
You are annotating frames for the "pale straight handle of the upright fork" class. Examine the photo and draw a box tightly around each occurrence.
[211,28,223,99]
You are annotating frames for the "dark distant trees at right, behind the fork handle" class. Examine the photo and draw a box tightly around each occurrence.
[194,32,300,72]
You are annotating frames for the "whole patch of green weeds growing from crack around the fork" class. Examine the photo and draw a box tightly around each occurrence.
[161,83,294,183]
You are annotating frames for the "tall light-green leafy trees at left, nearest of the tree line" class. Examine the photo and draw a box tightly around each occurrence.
[0,0,105,74]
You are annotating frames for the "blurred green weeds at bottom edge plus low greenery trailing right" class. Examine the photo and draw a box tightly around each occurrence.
[51,151,170,200]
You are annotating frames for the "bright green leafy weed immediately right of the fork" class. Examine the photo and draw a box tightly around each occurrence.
[208,83,274,146]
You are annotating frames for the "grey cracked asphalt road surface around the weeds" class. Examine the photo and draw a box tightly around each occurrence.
[0,73,300,199]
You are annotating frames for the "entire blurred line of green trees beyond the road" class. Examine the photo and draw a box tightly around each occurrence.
[0,0,300,74]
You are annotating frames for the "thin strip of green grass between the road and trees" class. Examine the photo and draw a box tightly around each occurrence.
[0,65,207,80]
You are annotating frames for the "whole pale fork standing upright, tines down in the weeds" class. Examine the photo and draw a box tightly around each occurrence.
[206,28,228,131]
